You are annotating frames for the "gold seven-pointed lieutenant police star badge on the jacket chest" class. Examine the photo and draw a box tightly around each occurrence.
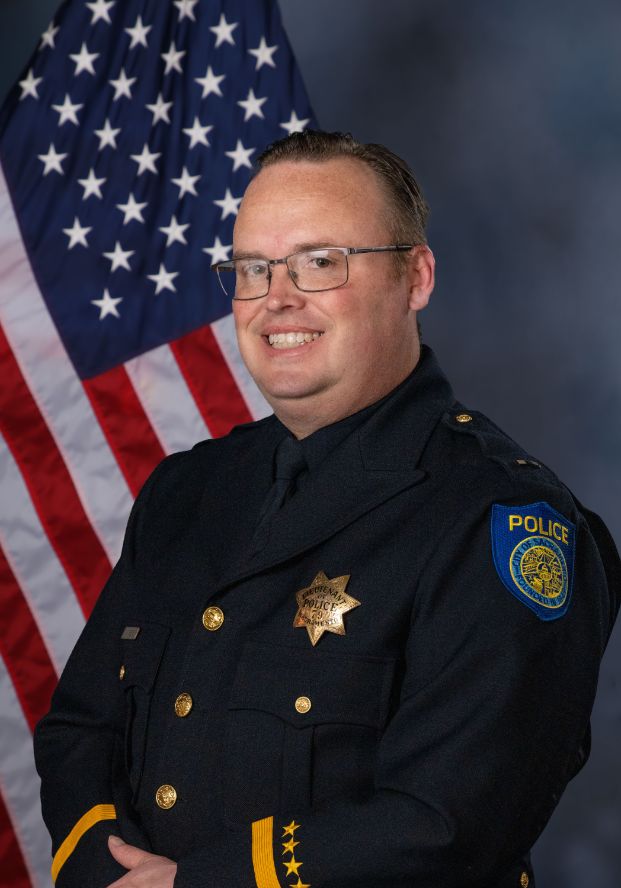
[293,570,360,647]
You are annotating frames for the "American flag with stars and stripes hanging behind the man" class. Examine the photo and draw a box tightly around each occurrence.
[0,0,313,888]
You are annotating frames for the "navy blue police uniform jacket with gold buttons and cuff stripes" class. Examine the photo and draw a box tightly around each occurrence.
[36,349,619,888]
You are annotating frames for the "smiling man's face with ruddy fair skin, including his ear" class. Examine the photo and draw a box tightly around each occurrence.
[233,158,433,437]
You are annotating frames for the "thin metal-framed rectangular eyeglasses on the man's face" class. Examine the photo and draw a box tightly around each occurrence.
[211,244,412,300]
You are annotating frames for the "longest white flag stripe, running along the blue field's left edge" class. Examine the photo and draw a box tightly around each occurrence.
[0,168,132,562]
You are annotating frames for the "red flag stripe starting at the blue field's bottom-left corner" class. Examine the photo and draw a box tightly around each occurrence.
[83,367,166,496]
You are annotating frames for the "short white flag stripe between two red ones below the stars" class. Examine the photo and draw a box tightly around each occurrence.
[125,345,210,453]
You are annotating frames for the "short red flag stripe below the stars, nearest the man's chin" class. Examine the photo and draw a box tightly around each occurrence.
[170,327,252,438]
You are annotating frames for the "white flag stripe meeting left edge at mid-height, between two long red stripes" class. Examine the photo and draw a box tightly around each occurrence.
[0,435,84,675]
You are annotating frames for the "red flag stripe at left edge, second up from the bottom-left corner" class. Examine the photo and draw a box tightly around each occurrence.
[0,549,57,728]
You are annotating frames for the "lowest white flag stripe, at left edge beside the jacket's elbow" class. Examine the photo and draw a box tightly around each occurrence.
[0,658,52,888]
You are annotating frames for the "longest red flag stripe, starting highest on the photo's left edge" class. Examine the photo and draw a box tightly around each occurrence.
[0,328,110,616]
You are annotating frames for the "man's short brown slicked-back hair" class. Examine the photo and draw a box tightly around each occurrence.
[256,130,429,244]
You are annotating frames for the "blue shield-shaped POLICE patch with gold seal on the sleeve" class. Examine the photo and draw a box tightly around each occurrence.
[491,502,576,620]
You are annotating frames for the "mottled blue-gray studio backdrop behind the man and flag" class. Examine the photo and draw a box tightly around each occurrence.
[0,0,621,888]
